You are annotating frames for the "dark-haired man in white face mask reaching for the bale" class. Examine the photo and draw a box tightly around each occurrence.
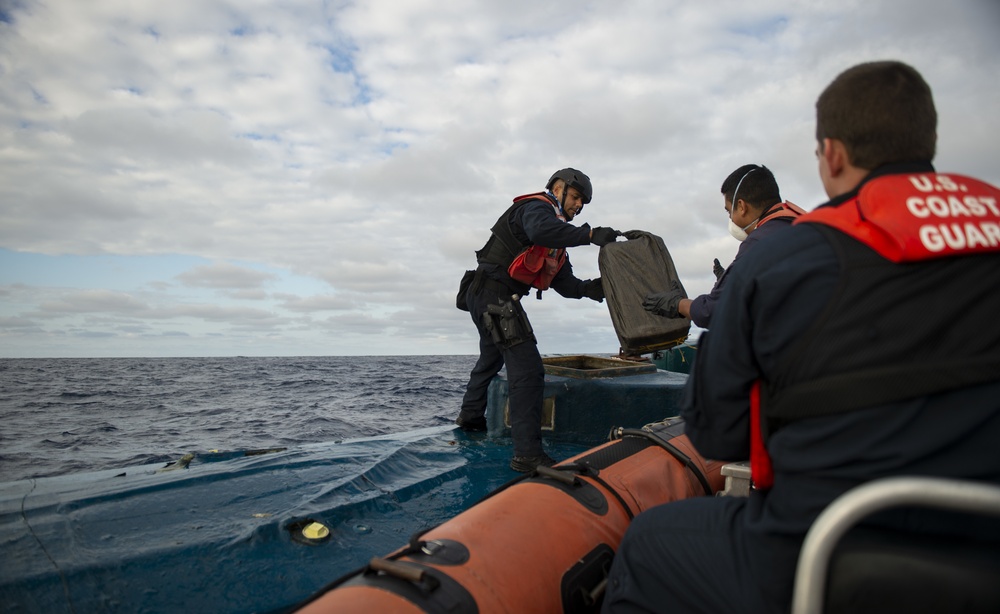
[642,164,805,328]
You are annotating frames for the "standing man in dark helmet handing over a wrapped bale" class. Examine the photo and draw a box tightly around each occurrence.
[455,168,621,472]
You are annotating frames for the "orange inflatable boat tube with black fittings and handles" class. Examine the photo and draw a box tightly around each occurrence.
[299,420,724,614]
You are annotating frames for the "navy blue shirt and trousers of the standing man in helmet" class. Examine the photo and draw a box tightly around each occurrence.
[459,200,590,456]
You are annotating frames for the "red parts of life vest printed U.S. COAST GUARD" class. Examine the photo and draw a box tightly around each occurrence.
[750,172,1000,489]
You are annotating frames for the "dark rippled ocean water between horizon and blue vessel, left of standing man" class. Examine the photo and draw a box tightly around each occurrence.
[0,356,476,482]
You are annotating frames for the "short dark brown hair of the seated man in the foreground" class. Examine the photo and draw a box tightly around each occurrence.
[816,61,937,170]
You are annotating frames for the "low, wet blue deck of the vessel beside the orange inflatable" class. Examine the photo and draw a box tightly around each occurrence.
[0,427,600,613]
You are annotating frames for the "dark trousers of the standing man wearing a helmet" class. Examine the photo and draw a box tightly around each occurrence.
[460,284,545,456]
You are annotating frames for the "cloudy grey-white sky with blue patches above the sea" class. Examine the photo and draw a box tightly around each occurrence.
[0,0,1000,357]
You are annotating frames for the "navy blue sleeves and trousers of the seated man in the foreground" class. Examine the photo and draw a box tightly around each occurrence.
[604,164,1000,613]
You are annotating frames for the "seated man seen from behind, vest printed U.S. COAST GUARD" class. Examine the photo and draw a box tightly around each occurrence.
[603,61,1000,614]
